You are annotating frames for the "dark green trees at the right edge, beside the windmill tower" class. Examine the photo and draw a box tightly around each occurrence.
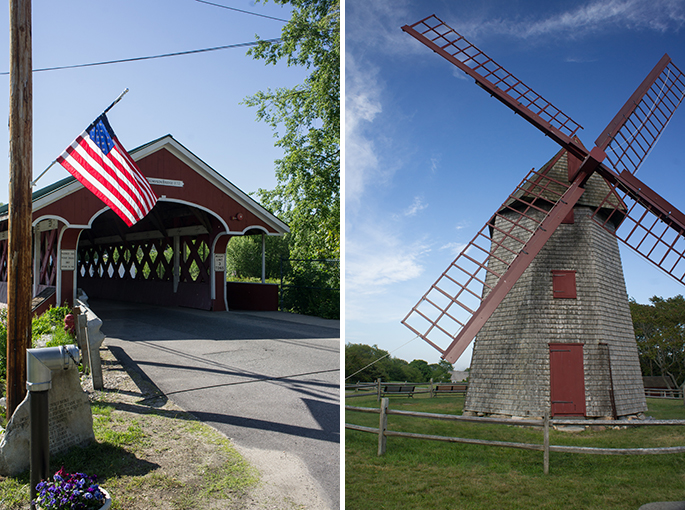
[630,296,685,385]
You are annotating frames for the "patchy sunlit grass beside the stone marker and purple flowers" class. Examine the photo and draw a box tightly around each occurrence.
[0,401,259,510]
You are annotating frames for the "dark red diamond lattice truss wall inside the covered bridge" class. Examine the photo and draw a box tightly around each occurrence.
[78,234,210,283]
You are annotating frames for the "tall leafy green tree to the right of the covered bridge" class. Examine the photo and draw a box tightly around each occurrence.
[244,0,340,258]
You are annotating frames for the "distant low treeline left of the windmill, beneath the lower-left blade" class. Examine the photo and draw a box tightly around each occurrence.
[345,344,453,383]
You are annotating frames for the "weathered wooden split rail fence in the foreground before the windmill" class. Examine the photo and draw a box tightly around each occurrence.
[345,398,685,474]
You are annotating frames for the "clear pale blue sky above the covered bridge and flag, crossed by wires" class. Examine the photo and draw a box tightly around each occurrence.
[0,0,306,203]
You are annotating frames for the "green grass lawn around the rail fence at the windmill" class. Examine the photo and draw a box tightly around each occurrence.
[345,395,685,510]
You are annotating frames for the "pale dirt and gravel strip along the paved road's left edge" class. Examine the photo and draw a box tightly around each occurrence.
[83,345,327,510]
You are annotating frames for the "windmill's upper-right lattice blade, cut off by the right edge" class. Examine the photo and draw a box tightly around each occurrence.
[595,55,685,174]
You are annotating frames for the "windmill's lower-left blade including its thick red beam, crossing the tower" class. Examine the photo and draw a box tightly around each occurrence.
[402,159,583,363]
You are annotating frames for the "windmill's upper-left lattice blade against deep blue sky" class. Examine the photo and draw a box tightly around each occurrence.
[402,15,587,159]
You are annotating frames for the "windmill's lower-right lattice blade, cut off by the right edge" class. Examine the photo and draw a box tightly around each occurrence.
[593,167,685,283]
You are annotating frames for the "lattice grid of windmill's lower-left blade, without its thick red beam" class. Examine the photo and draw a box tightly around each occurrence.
[402,167,569,354]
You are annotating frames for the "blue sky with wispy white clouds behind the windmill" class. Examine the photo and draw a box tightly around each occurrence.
[345,0,685,369]
